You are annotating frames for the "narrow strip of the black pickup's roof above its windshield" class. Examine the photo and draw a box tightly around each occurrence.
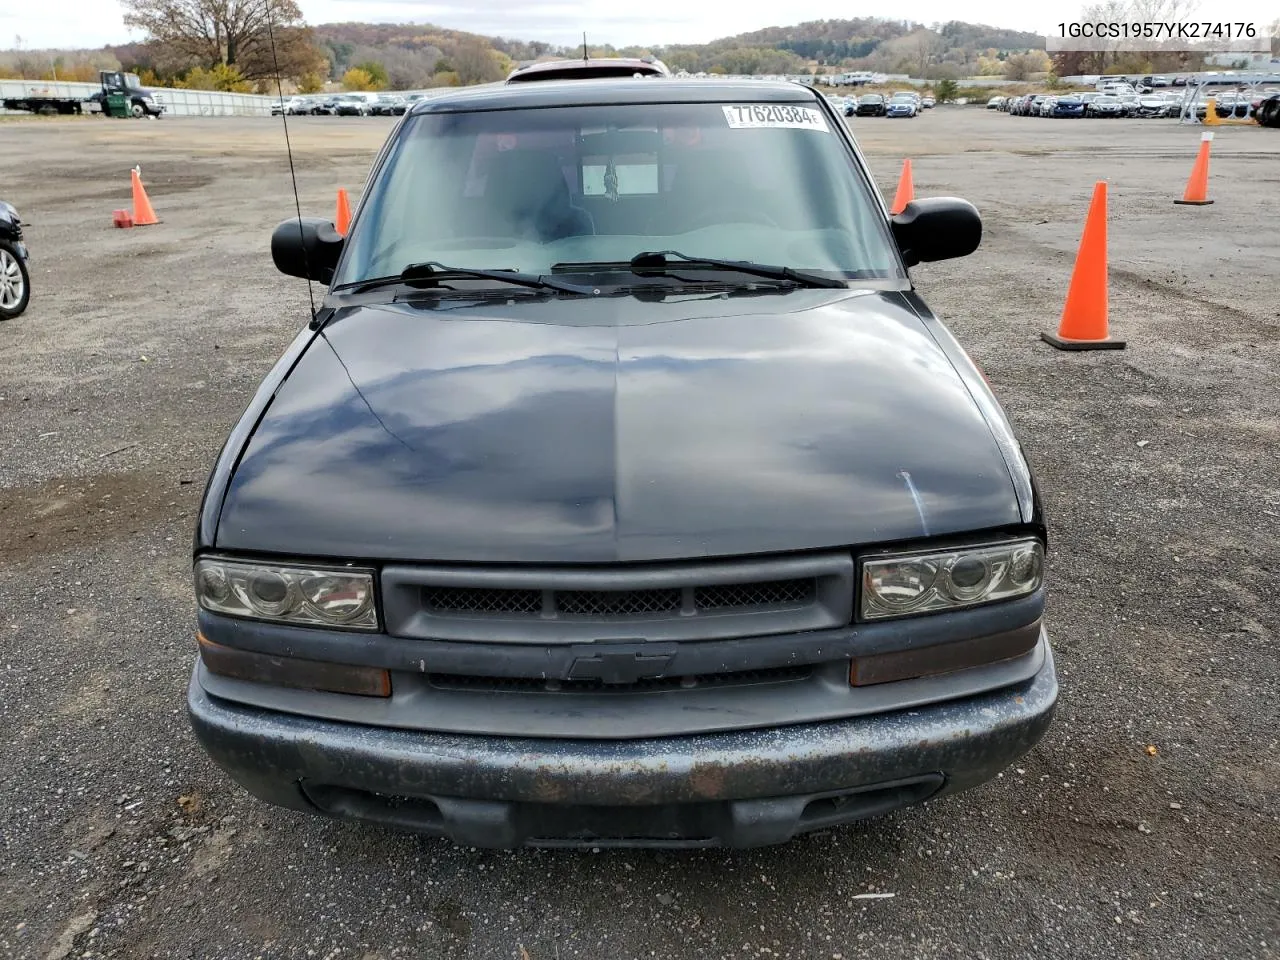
[410,77,819,114]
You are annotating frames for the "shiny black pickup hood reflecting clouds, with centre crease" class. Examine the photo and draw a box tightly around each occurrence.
[215,289,1020,563]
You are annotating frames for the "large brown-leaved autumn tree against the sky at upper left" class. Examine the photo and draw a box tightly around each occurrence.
[124,0,325,79]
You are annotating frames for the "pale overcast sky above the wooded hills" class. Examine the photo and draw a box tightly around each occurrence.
[0,0,1280,49]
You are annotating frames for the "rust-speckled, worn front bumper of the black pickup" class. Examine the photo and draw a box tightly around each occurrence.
[187,640,1057,849]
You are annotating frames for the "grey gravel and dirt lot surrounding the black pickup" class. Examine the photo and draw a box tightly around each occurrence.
[0,108,1280,960]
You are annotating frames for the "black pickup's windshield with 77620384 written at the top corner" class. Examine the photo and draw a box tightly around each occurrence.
[334,104,902,285]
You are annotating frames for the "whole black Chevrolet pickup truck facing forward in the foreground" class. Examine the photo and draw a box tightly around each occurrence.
[187,78,1057,847]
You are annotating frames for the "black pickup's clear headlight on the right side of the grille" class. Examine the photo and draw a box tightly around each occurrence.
[859,540,1044,621]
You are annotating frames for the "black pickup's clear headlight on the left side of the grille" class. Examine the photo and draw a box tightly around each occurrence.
[196,559,379,630]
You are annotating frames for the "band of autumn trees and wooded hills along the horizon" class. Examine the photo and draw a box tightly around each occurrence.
[0,0,1259,93]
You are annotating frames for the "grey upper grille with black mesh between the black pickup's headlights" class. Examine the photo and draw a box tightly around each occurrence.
[381,552,854,644]
